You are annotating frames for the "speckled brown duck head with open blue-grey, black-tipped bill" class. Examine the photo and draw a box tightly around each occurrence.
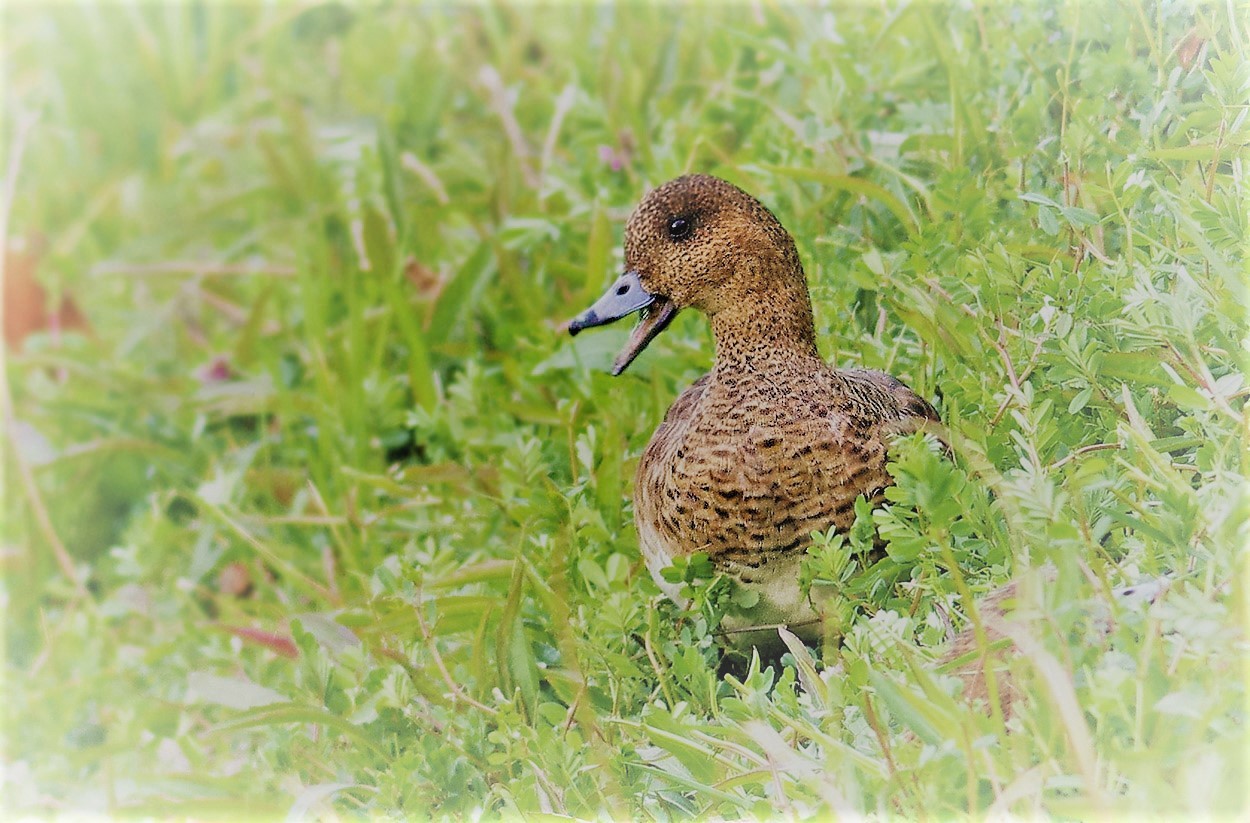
[569,174,811,375]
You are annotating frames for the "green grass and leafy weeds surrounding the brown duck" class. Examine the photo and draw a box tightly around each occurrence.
[3,0,1250,819]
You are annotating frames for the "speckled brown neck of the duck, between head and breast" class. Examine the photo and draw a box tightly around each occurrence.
[711,281,820,369]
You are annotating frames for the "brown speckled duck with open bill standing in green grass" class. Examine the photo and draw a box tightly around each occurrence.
[568,174,939,650]
